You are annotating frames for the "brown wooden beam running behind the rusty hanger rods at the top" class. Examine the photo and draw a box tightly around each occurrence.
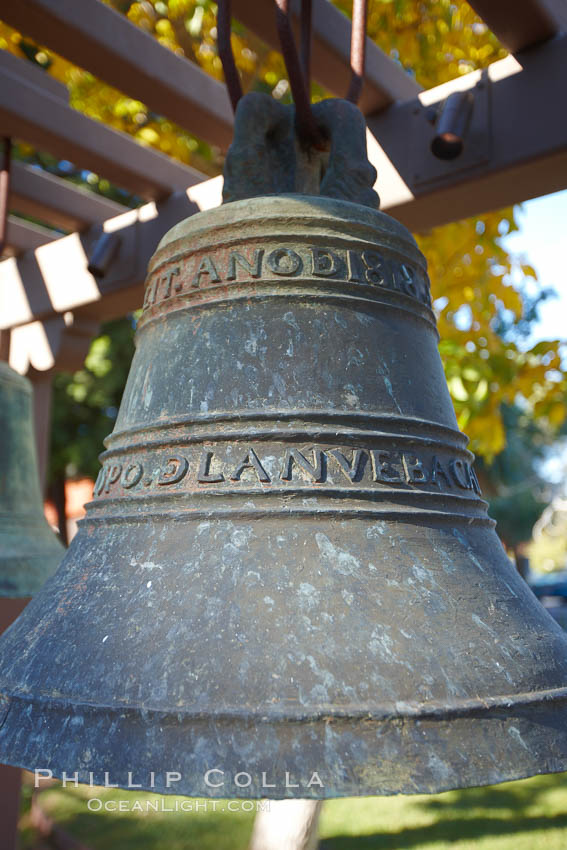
[232,0,421,115]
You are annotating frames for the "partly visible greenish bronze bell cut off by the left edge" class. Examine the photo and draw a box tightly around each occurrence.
[0,362,64,599]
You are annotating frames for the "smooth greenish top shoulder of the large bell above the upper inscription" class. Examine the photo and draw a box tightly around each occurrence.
[153,192,427,262]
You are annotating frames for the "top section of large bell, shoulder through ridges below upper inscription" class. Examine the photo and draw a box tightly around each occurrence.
[139,196,435,328]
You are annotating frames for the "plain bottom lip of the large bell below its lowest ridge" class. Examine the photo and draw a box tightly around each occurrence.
[0,688,567,799]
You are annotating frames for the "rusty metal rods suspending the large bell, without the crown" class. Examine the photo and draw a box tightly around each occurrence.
[217,0,368,150]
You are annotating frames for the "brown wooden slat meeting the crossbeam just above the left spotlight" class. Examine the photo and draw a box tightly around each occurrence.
[10,162,127,230]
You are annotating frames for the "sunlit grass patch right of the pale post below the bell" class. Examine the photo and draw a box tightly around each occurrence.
[320,774,567,850]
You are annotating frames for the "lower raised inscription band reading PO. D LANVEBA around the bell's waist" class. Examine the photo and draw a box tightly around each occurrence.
[95,444,480,496]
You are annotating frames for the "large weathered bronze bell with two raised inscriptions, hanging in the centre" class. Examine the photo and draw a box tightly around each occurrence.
[0,96,567,798]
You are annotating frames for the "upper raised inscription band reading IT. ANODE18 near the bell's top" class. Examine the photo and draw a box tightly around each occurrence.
[144,245,431,309]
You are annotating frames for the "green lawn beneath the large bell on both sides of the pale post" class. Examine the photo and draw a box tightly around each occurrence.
[21,774,567,850]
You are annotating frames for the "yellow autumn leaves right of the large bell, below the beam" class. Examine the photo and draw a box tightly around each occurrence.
[418,215,566,460]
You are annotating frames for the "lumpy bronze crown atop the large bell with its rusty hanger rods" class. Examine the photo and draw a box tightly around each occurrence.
[218,0,379,209]
